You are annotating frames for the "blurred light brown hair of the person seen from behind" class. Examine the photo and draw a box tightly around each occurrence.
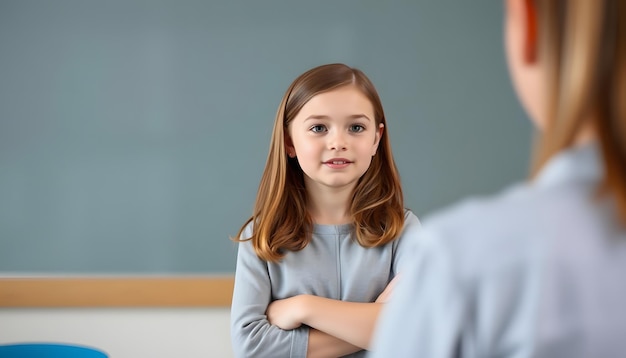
[533,0,626,224]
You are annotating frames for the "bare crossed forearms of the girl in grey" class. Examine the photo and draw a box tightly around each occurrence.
[266,276,398,357]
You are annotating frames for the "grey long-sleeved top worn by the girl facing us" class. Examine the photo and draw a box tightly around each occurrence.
[231,210,420,358]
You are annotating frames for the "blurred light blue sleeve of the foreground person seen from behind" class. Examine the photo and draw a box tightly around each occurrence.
[368,230,466,358]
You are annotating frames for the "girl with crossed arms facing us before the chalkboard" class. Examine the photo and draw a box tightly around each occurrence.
[231,64,419,357]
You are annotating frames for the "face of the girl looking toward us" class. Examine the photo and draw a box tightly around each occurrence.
[285,85,384,193]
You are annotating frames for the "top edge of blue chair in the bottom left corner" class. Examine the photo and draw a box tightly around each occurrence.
[0,343,108,358]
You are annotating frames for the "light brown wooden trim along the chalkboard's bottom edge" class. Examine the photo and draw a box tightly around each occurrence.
[0,276,234,307]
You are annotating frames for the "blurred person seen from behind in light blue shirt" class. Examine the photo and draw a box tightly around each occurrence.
[373,0,626,358]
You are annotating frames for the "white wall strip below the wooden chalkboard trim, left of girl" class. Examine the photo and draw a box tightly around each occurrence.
[0,308,233,358]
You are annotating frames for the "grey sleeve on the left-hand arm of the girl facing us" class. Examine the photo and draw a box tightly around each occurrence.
[230,227,309,358]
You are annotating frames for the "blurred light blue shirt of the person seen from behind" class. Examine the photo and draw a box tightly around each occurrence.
[368,145,626,358]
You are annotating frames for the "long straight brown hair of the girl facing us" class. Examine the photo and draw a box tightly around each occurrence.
[235,64,404,262]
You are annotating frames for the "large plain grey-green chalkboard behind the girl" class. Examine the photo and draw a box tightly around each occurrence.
[0,0,531,274]
